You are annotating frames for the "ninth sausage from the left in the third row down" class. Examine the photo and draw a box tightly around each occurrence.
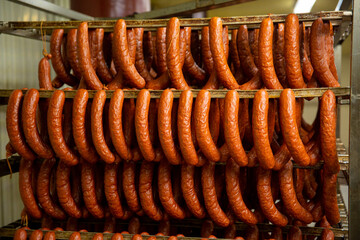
[181,163,205,218]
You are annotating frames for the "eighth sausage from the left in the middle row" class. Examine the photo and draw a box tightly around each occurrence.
[157,89,181,165]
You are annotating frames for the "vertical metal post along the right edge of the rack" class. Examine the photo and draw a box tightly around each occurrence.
[349,0,360,239]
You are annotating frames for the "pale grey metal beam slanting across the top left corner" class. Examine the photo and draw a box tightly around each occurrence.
[8,0,95,21]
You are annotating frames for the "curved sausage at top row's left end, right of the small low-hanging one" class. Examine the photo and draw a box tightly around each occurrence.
[50,29,78,86]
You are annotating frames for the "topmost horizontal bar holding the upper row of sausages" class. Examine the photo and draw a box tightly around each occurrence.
[0,11,352,32]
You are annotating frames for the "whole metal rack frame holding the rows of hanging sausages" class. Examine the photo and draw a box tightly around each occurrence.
[0,4,354,240]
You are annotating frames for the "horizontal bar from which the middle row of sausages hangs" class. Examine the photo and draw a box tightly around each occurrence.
[0,87,350,103]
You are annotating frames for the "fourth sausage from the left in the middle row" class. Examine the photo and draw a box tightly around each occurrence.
[72,89,99,163]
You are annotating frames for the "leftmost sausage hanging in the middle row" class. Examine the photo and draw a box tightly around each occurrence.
[6,89,36,161]
